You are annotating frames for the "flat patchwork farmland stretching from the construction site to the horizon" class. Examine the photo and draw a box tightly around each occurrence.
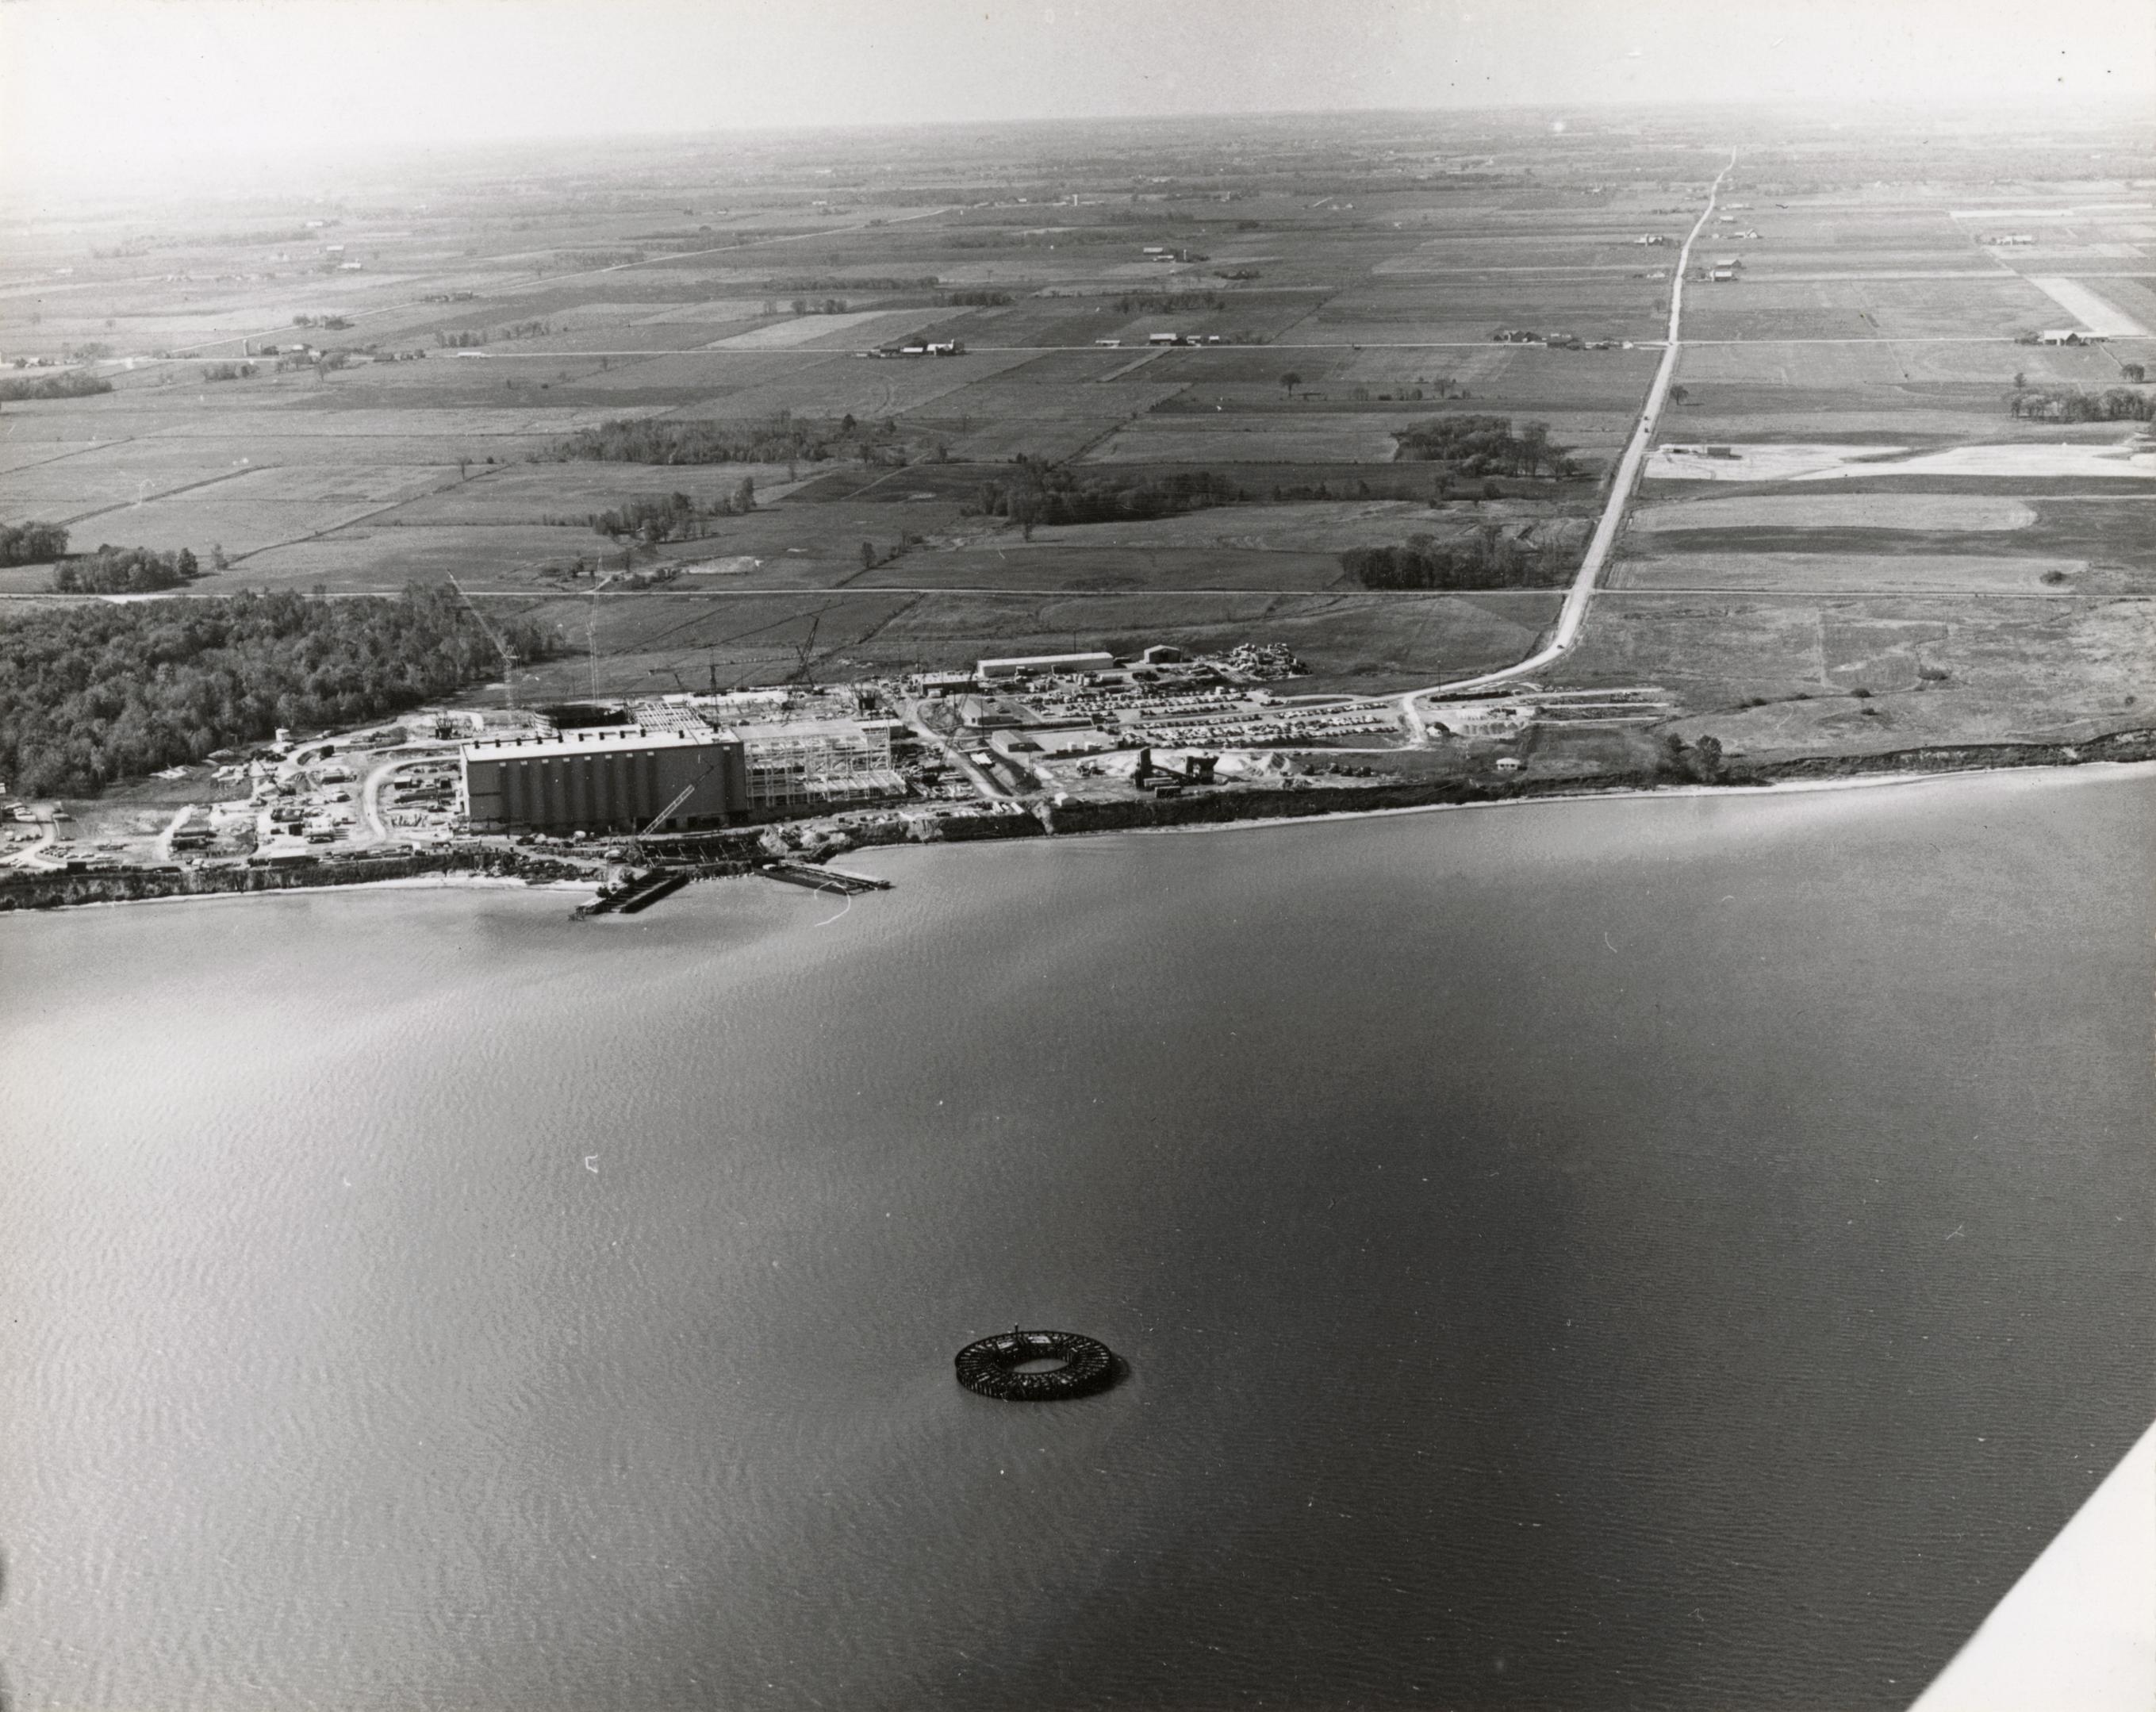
[0,112,2156,753]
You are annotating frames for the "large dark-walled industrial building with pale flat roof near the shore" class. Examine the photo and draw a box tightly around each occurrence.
[463,727,748,832]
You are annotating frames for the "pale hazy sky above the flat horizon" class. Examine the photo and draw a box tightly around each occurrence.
[0,0,2156,194]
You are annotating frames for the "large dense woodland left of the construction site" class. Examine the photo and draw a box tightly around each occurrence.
[0,585,556,796]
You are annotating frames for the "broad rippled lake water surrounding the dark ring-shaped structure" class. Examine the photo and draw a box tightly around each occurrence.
[0,770,2156,1712]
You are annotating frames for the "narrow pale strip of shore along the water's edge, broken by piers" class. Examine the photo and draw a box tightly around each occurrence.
[0,733,2156,916]
